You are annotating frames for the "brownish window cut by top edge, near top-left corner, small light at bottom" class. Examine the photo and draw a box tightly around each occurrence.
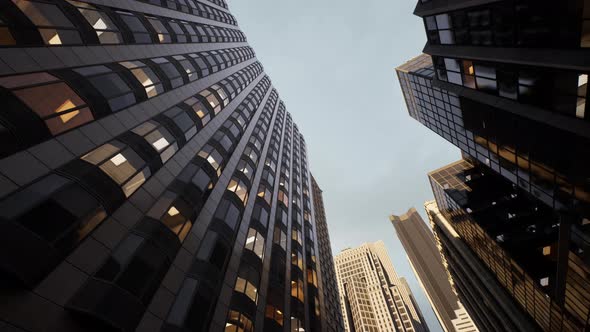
[12,0,82,45]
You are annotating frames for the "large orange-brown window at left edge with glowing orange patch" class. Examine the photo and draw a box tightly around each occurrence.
[0,72,94,135]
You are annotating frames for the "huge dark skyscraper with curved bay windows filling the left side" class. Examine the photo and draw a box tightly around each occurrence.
[0,0,329,332]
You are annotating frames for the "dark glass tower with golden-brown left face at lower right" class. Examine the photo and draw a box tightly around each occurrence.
[429,159,590,331]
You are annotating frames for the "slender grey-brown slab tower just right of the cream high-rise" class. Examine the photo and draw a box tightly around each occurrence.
[389,208,477,332]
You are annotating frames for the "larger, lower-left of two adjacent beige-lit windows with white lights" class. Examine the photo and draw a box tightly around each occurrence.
[81,140,151,197]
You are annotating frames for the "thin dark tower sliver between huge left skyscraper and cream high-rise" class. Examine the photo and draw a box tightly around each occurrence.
[311,175,344,332]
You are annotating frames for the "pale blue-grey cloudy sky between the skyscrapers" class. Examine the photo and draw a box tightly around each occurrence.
[229,0,460,331]
